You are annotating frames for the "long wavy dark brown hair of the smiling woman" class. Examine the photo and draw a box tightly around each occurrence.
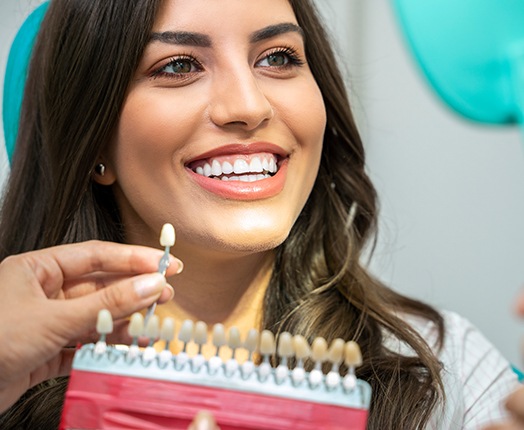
[0,0,444,430]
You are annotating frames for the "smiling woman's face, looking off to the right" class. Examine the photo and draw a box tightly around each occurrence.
[106,0,327,254]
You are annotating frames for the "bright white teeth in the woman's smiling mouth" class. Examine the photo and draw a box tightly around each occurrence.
[193,156,278,182]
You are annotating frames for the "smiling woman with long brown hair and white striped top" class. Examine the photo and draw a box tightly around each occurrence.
[0,0,516,430]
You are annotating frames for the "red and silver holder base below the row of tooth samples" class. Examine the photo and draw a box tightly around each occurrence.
[62,344,371,430]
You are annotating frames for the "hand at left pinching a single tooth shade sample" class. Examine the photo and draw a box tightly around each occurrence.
[0,241,182,411]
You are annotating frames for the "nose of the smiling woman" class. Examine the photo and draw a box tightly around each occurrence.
[209,65,274,130]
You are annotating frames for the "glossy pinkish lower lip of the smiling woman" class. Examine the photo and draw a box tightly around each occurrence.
[187,160,287,200]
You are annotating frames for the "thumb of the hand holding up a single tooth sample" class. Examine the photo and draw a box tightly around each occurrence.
[62,273,167,330]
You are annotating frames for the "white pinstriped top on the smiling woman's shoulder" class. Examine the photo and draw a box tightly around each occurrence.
[406,310,518,429]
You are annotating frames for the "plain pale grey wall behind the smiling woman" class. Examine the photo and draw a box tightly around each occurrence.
[0,0,524,362]
